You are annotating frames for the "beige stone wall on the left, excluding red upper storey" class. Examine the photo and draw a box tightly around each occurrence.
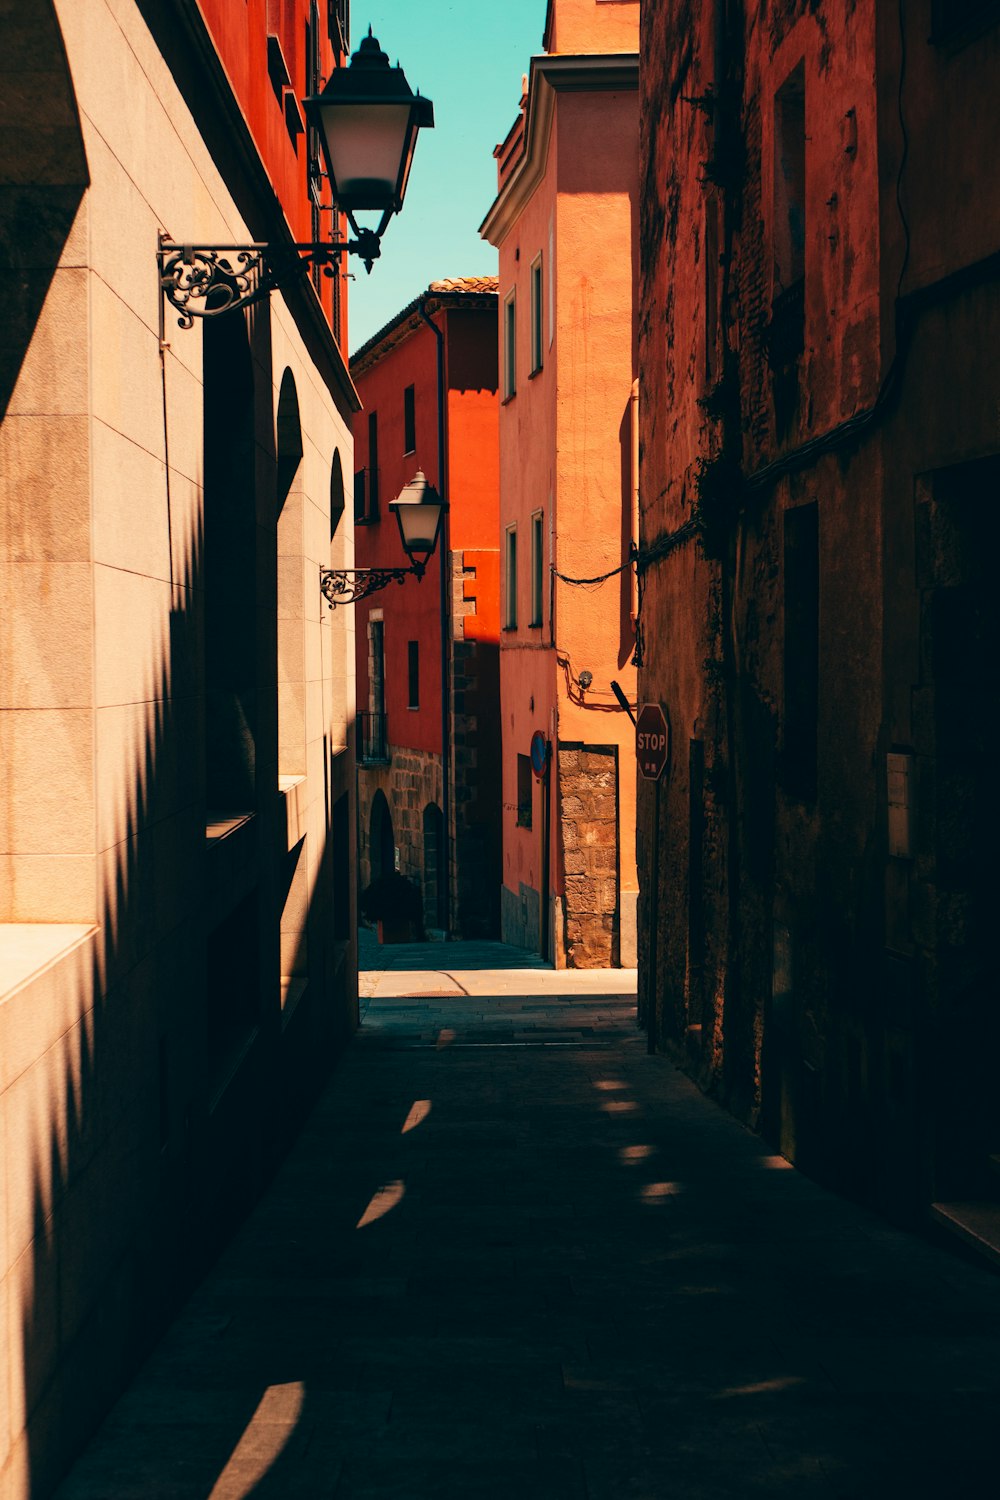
[0,0,357,1500]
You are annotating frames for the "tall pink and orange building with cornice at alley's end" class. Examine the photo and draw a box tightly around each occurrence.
[480,0,639,968]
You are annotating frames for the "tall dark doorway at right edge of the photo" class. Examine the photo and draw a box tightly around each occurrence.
[918,458,1000,1197]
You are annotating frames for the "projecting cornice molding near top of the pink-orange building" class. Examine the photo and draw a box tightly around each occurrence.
[480,53,639,249]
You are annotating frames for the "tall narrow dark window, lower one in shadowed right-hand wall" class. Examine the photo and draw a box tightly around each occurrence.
[783,504,820,803]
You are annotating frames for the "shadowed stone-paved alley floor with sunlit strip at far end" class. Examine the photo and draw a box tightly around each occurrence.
[60,945,1000,1500]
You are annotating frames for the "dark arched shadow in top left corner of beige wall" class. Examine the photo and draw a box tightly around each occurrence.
[0,0,90,420]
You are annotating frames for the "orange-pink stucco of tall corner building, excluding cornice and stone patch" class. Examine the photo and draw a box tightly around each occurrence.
[499,23,639,963]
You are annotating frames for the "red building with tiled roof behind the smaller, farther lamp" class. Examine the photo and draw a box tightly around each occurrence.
[351,278,509,938]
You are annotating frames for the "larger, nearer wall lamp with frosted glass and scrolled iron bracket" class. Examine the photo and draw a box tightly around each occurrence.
[157,27,433,329]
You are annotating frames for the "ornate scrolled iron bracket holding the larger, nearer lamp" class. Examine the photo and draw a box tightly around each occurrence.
[156,225,382,329]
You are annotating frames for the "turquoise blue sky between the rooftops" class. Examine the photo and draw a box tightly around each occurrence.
[348,0,546,350]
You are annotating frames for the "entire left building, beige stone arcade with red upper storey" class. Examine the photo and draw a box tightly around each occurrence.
[0,0,357,1500]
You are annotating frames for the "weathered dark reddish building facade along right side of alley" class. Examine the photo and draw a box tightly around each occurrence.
[639,0,1000,1223]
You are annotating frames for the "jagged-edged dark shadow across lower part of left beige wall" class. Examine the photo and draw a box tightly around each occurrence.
[12,225,351,1496]
